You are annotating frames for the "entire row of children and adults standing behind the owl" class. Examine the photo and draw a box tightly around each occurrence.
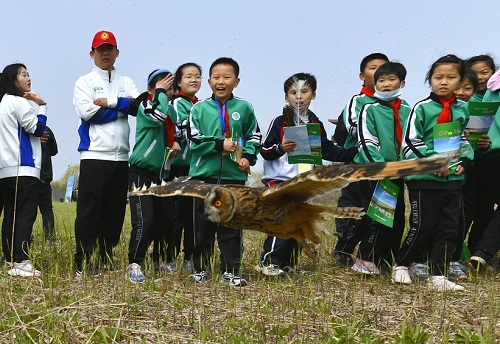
[0,31,500,291]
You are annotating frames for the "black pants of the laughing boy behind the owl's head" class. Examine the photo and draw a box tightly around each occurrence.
[193,181,244,274]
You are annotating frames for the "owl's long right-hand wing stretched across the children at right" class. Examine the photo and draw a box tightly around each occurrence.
[261,155,452,202]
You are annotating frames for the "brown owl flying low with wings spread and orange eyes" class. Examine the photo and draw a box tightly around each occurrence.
[131,156,451,257]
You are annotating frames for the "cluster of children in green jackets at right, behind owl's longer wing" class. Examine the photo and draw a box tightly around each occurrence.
[332,53,500,291]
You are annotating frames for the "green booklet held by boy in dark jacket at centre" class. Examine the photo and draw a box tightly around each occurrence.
[284,123,323,165]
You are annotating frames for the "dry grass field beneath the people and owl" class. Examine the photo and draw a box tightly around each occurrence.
[0,199,500,343]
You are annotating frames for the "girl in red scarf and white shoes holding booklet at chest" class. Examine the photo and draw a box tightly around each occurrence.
[393,55,473,291]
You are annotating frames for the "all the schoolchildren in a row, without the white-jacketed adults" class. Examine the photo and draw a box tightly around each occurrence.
[73,44,500,291]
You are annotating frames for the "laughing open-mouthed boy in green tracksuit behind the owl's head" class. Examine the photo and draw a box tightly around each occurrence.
[188,57,262,287]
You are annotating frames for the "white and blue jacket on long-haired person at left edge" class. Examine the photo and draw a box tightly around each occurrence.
[0,94,47,179]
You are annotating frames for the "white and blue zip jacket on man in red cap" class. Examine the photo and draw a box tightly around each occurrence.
[73,66,139,161]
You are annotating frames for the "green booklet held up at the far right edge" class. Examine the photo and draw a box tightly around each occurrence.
[466,102,500,149]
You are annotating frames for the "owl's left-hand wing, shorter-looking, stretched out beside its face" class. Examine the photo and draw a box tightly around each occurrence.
[130,177,214,198]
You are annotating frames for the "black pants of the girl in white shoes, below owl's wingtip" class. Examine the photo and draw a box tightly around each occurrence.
[396,188,463,275]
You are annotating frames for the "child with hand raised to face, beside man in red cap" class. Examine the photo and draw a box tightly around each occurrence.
[126,69,180,283]
